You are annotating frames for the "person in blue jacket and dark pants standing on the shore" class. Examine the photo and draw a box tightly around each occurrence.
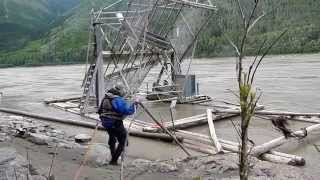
[98,85,135,165]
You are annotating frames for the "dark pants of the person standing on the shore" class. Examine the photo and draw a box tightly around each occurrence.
[106,121,127,162]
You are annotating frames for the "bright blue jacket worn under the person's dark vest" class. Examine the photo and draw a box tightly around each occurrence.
[100,96,135,128]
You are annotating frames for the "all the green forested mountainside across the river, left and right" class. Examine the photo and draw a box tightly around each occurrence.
[0,0,320,66]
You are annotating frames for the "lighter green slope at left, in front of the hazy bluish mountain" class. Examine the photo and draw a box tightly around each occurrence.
[0,0,112,67]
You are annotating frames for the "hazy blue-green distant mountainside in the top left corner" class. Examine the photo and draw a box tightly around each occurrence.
[0,0,79,52]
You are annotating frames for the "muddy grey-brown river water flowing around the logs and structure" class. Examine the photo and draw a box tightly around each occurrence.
[0,54,320,177]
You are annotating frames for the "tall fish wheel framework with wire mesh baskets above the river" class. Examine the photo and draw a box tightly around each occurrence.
[80,0,216,114]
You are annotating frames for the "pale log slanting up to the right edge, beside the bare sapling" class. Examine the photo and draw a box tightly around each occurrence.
[251,124,320,156]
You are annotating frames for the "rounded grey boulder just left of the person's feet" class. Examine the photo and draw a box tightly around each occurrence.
[85,144,111,167]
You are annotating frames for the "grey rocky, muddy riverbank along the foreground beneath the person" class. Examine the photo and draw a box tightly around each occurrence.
[0,114,312,180]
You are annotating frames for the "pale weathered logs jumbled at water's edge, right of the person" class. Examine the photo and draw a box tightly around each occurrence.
[143,109,320,166]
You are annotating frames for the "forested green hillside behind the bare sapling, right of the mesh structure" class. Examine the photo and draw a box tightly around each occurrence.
[197,0,320,57]
